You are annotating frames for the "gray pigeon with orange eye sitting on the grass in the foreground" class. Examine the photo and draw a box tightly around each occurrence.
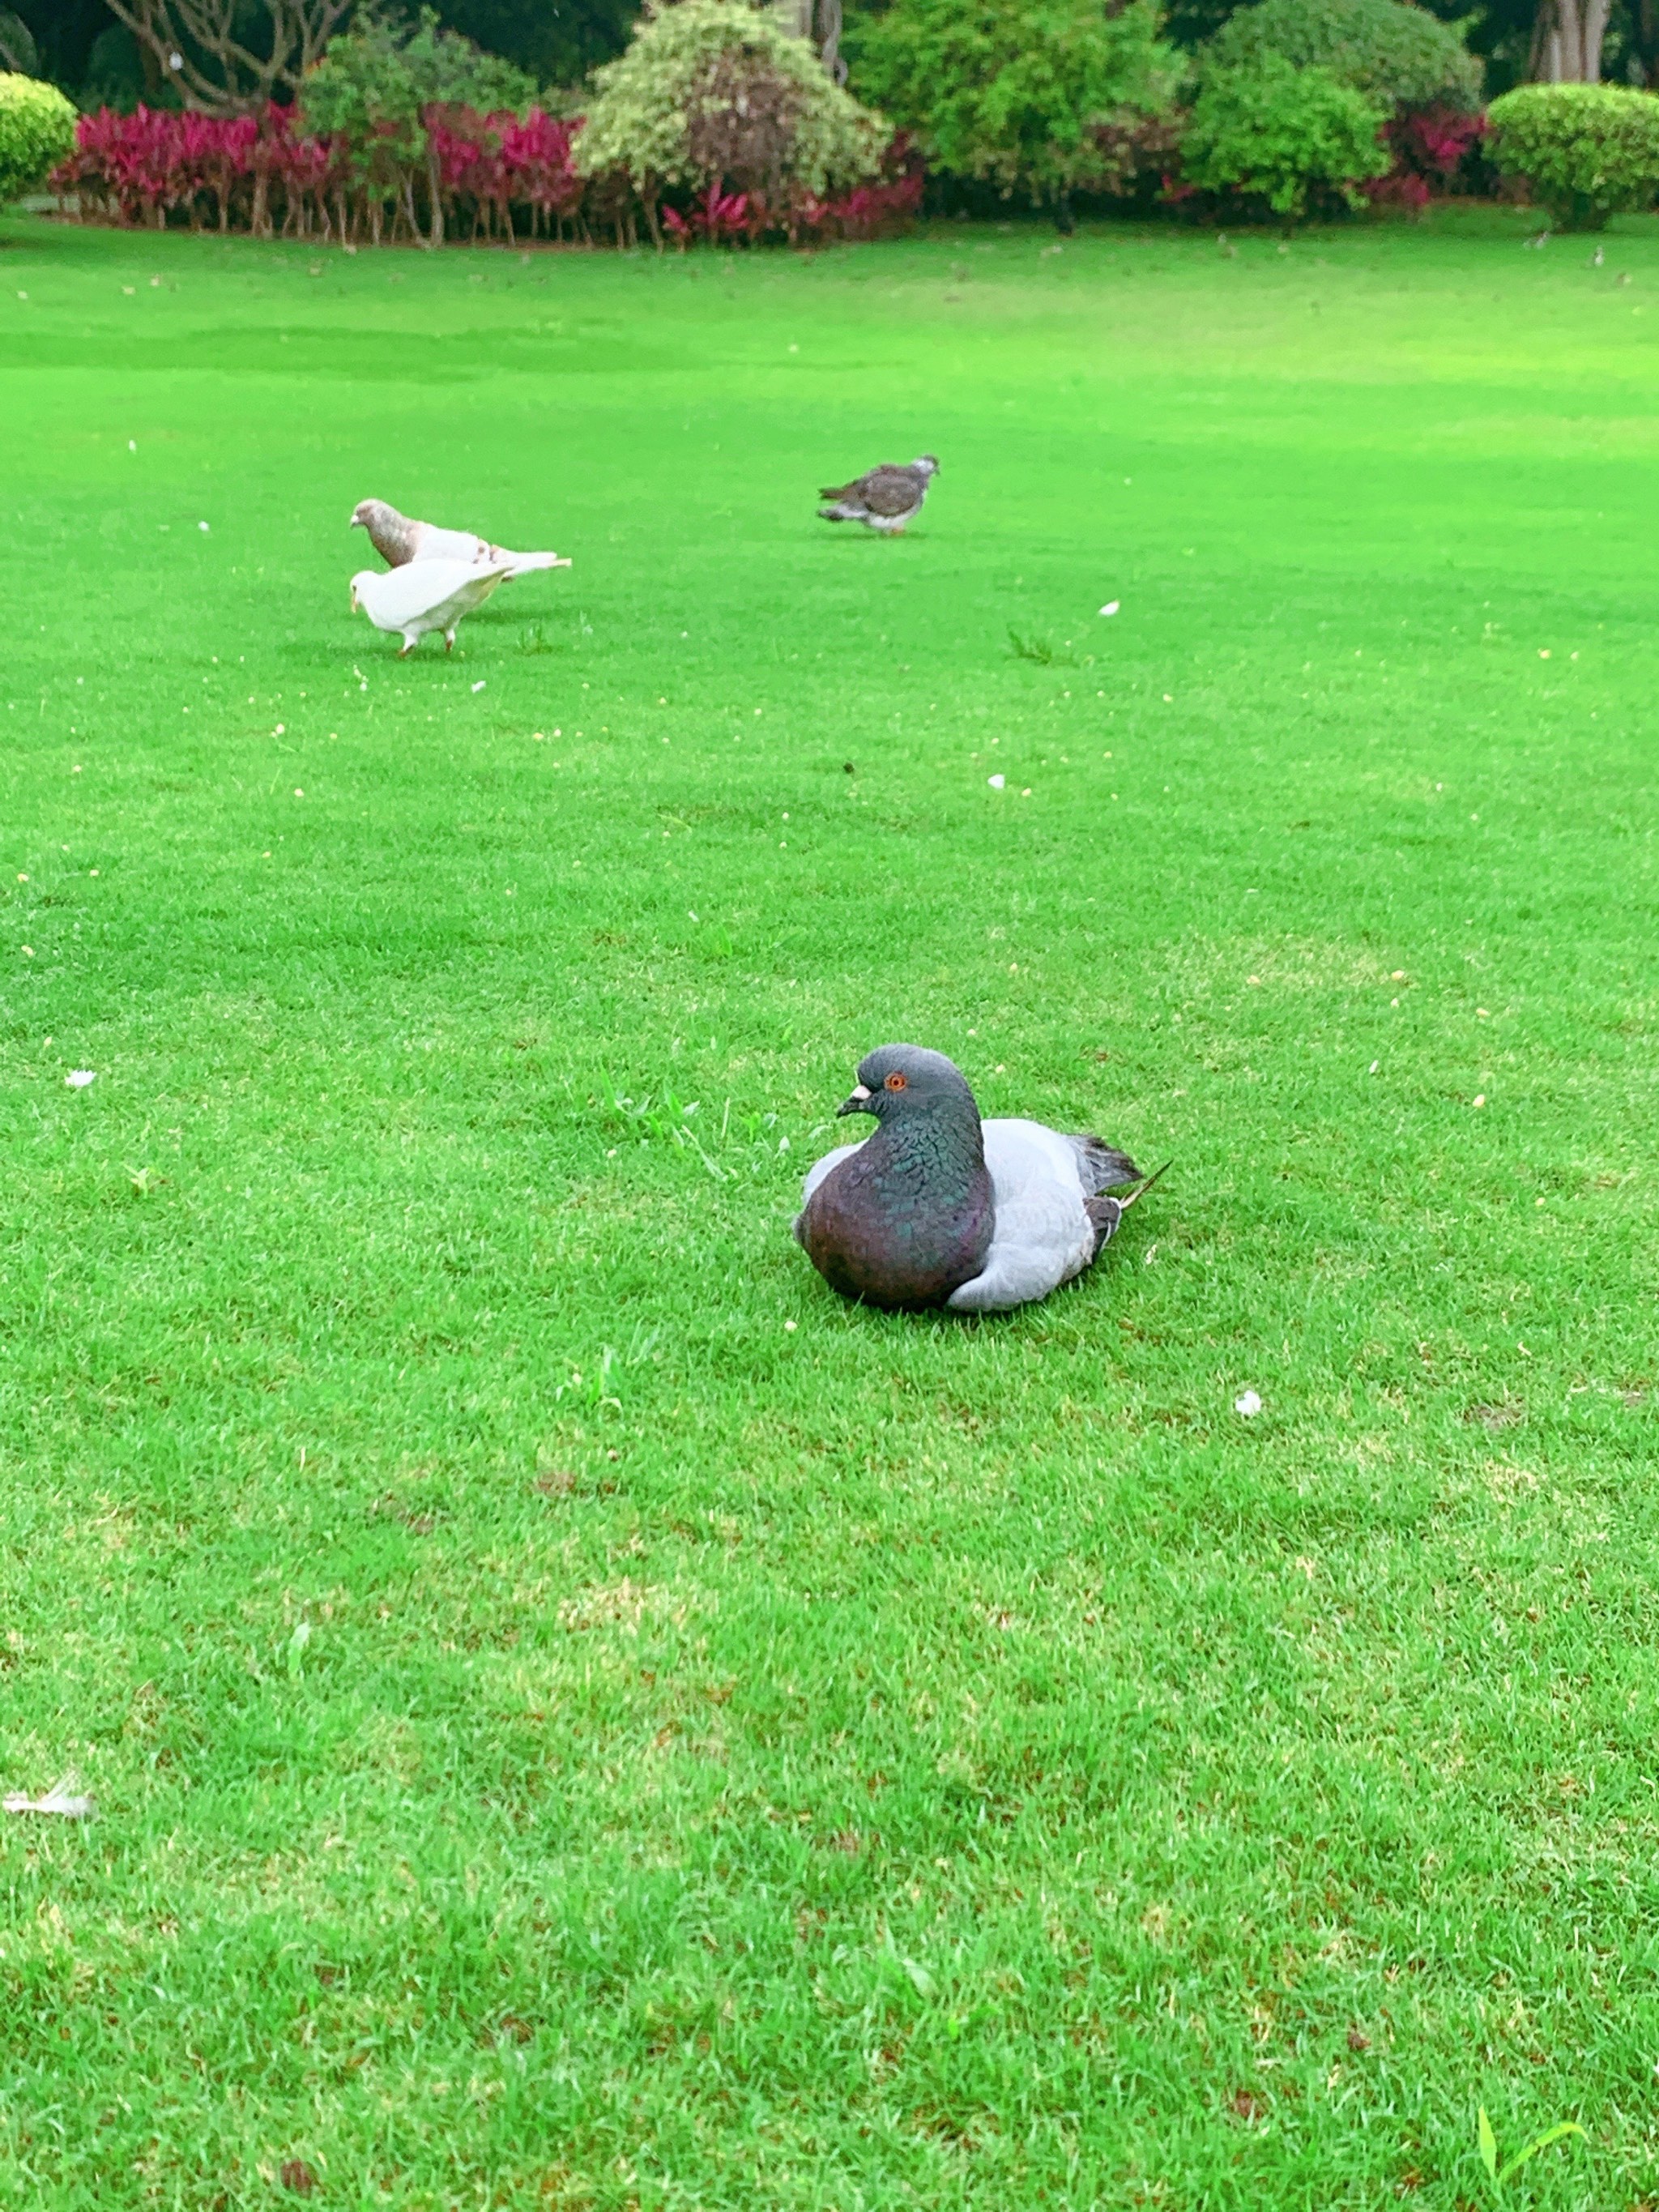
[794,1044,1163,1314]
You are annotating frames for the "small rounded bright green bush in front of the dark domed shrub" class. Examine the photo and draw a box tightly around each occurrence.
[1181,53,1392,219]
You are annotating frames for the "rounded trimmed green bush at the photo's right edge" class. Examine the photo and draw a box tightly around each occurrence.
[1491,84,1659,230]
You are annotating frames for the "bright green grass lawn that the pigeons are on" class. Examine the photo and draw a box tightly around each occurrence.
[0,199,1659,2212]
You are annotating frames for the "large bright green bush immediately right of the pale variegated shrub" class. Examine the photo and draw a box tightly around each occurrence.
[847,0,1175,201]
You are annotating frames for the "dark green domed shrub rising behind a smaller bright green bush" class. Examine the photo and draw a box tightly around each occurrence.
[1203,0,1480,113]
